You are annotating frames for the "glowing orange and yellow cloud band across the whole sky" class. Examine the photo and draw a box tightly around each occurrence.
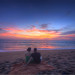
[0,26,75,40]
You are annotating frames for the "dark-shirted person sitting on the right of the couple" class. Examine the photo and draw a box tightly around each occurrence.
[31,48,41,64]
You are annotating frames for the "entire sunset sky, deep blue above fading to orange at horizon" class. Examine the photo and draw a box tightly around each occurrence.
[0,0,75,40]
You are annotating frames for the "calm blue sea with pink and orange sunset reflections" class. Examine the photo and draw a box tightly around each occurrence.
[0,40,75,51]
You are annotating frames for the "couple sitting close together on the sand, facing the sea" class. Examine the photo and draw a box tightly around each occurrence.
[25,47,42,64]
